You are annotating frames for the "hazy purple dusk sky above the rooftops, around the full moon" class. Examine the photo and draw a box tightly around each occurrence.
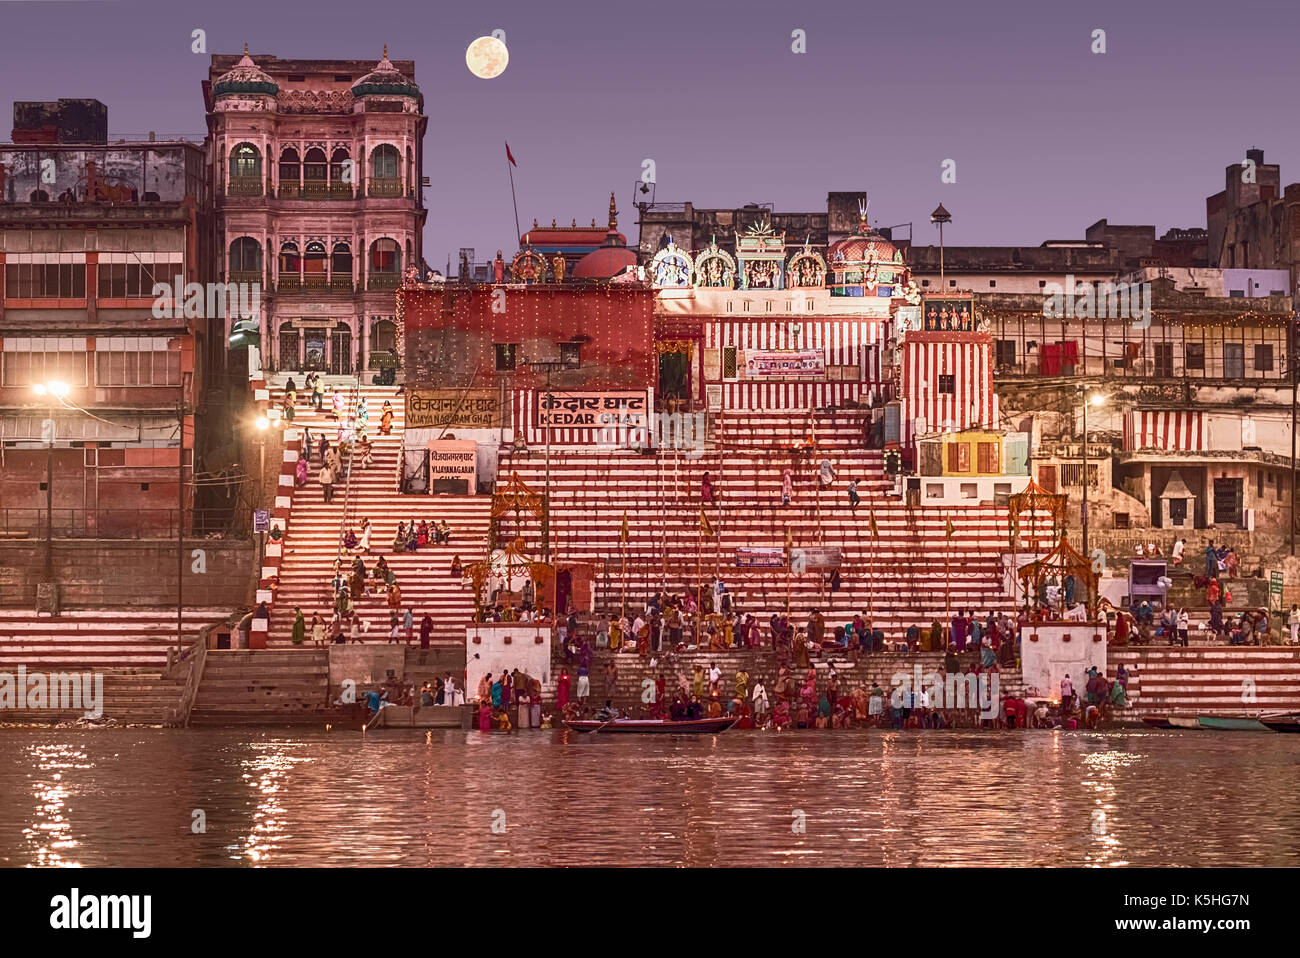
[0,0,1300,268]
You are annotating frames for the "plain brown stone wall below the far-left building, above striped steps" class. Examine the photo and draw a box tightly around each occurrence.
[0,539,255,608]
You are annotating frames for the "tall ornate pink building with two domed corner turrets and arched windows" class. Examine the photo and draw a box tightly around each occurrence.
[204,48,426,373]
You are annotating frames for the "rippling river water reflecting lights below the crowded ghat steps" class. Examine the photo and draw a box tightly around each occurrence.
[0,729,1300,867]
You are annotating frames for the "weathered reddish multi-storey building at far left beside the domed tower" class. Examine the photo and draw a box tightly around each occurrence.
[0,100,215,537]
